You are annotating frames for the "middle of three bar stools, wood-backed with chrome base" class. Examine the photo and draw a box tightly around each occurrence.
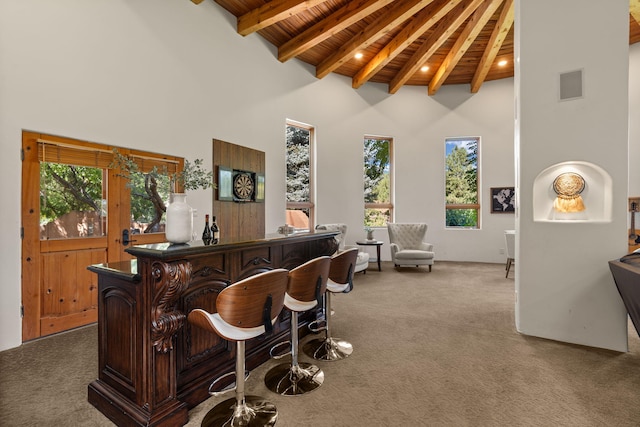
[264,256,331,396]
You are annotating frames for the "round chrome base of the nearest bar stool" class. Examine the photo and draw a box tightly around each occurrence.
[201,396,278,427]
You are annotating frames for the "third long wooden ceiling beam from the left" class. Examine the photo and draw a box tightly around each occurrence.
[316,0,433,79]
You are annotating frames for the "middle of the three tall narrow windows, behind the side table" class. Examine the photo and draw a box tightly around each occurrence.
[364,136,393,227]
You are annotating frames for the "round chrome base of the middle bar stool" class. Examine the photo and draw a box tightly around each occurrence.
[264,363,324,396]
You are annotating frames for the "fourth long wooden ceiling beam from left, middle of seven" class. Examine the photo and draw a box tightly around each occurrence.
[351,0,462,89]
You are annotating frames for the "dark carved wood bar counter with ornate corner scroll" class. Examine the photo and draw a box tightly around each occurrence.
[88,232,337,426]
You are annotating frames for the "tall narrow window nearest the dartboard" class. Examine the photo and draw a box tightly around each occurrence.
[286,121,314,230]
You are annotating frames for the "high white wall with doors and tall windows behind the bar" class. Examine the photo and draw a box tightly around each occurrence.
[0,0,640,350]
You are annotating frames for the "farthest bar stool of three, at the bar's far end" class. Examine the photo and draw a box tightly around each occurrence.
[302,248,358,361]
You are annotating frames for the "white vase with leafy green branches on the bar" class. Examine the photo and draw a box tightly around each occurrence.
[111,149,216,244]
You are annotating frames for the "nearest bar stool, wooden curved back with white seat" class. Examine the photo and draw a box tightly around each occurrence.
[188,268,289,427]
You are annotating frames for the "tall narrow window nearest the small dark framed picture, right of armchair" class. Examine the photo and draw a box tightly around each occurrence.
[445,137,480,228]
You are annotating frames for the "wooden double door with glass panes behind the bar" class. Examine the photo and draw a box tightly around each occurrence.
[21,131,183,341]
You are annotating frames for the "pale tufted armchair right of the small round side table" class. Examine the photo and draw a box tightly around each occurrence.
[387,222,435,271]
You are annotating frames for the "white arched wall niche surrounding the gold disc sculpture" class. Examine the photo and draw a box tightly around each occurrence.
[533,161,613,223]
